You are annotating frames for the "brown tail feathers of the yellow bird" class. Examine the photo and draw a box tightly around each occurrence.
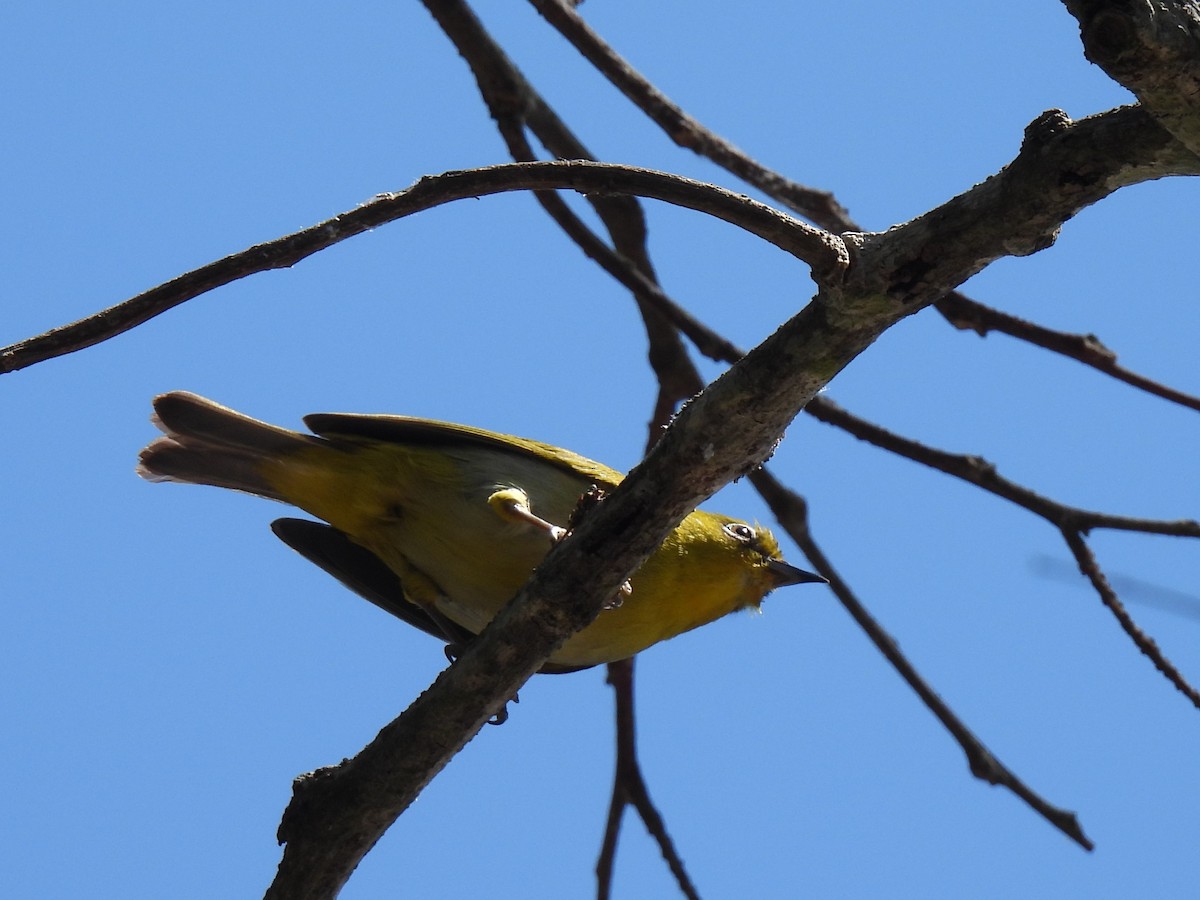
[138,391,325,502]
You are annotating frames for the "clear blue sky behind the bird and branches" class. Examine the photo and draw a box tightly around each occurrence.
[0,0,1200,898]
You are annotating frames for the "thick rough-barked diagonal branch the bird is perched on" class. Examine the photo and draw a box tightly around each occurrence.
[260,97,1190,884]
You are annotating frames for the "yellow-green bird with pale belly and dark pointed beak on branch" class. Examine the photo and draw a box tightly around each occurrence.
[138,391,824,672]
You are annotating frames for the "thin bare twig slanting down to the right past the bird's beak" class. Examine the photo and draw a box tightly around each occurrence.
[750,468,1094,851]
